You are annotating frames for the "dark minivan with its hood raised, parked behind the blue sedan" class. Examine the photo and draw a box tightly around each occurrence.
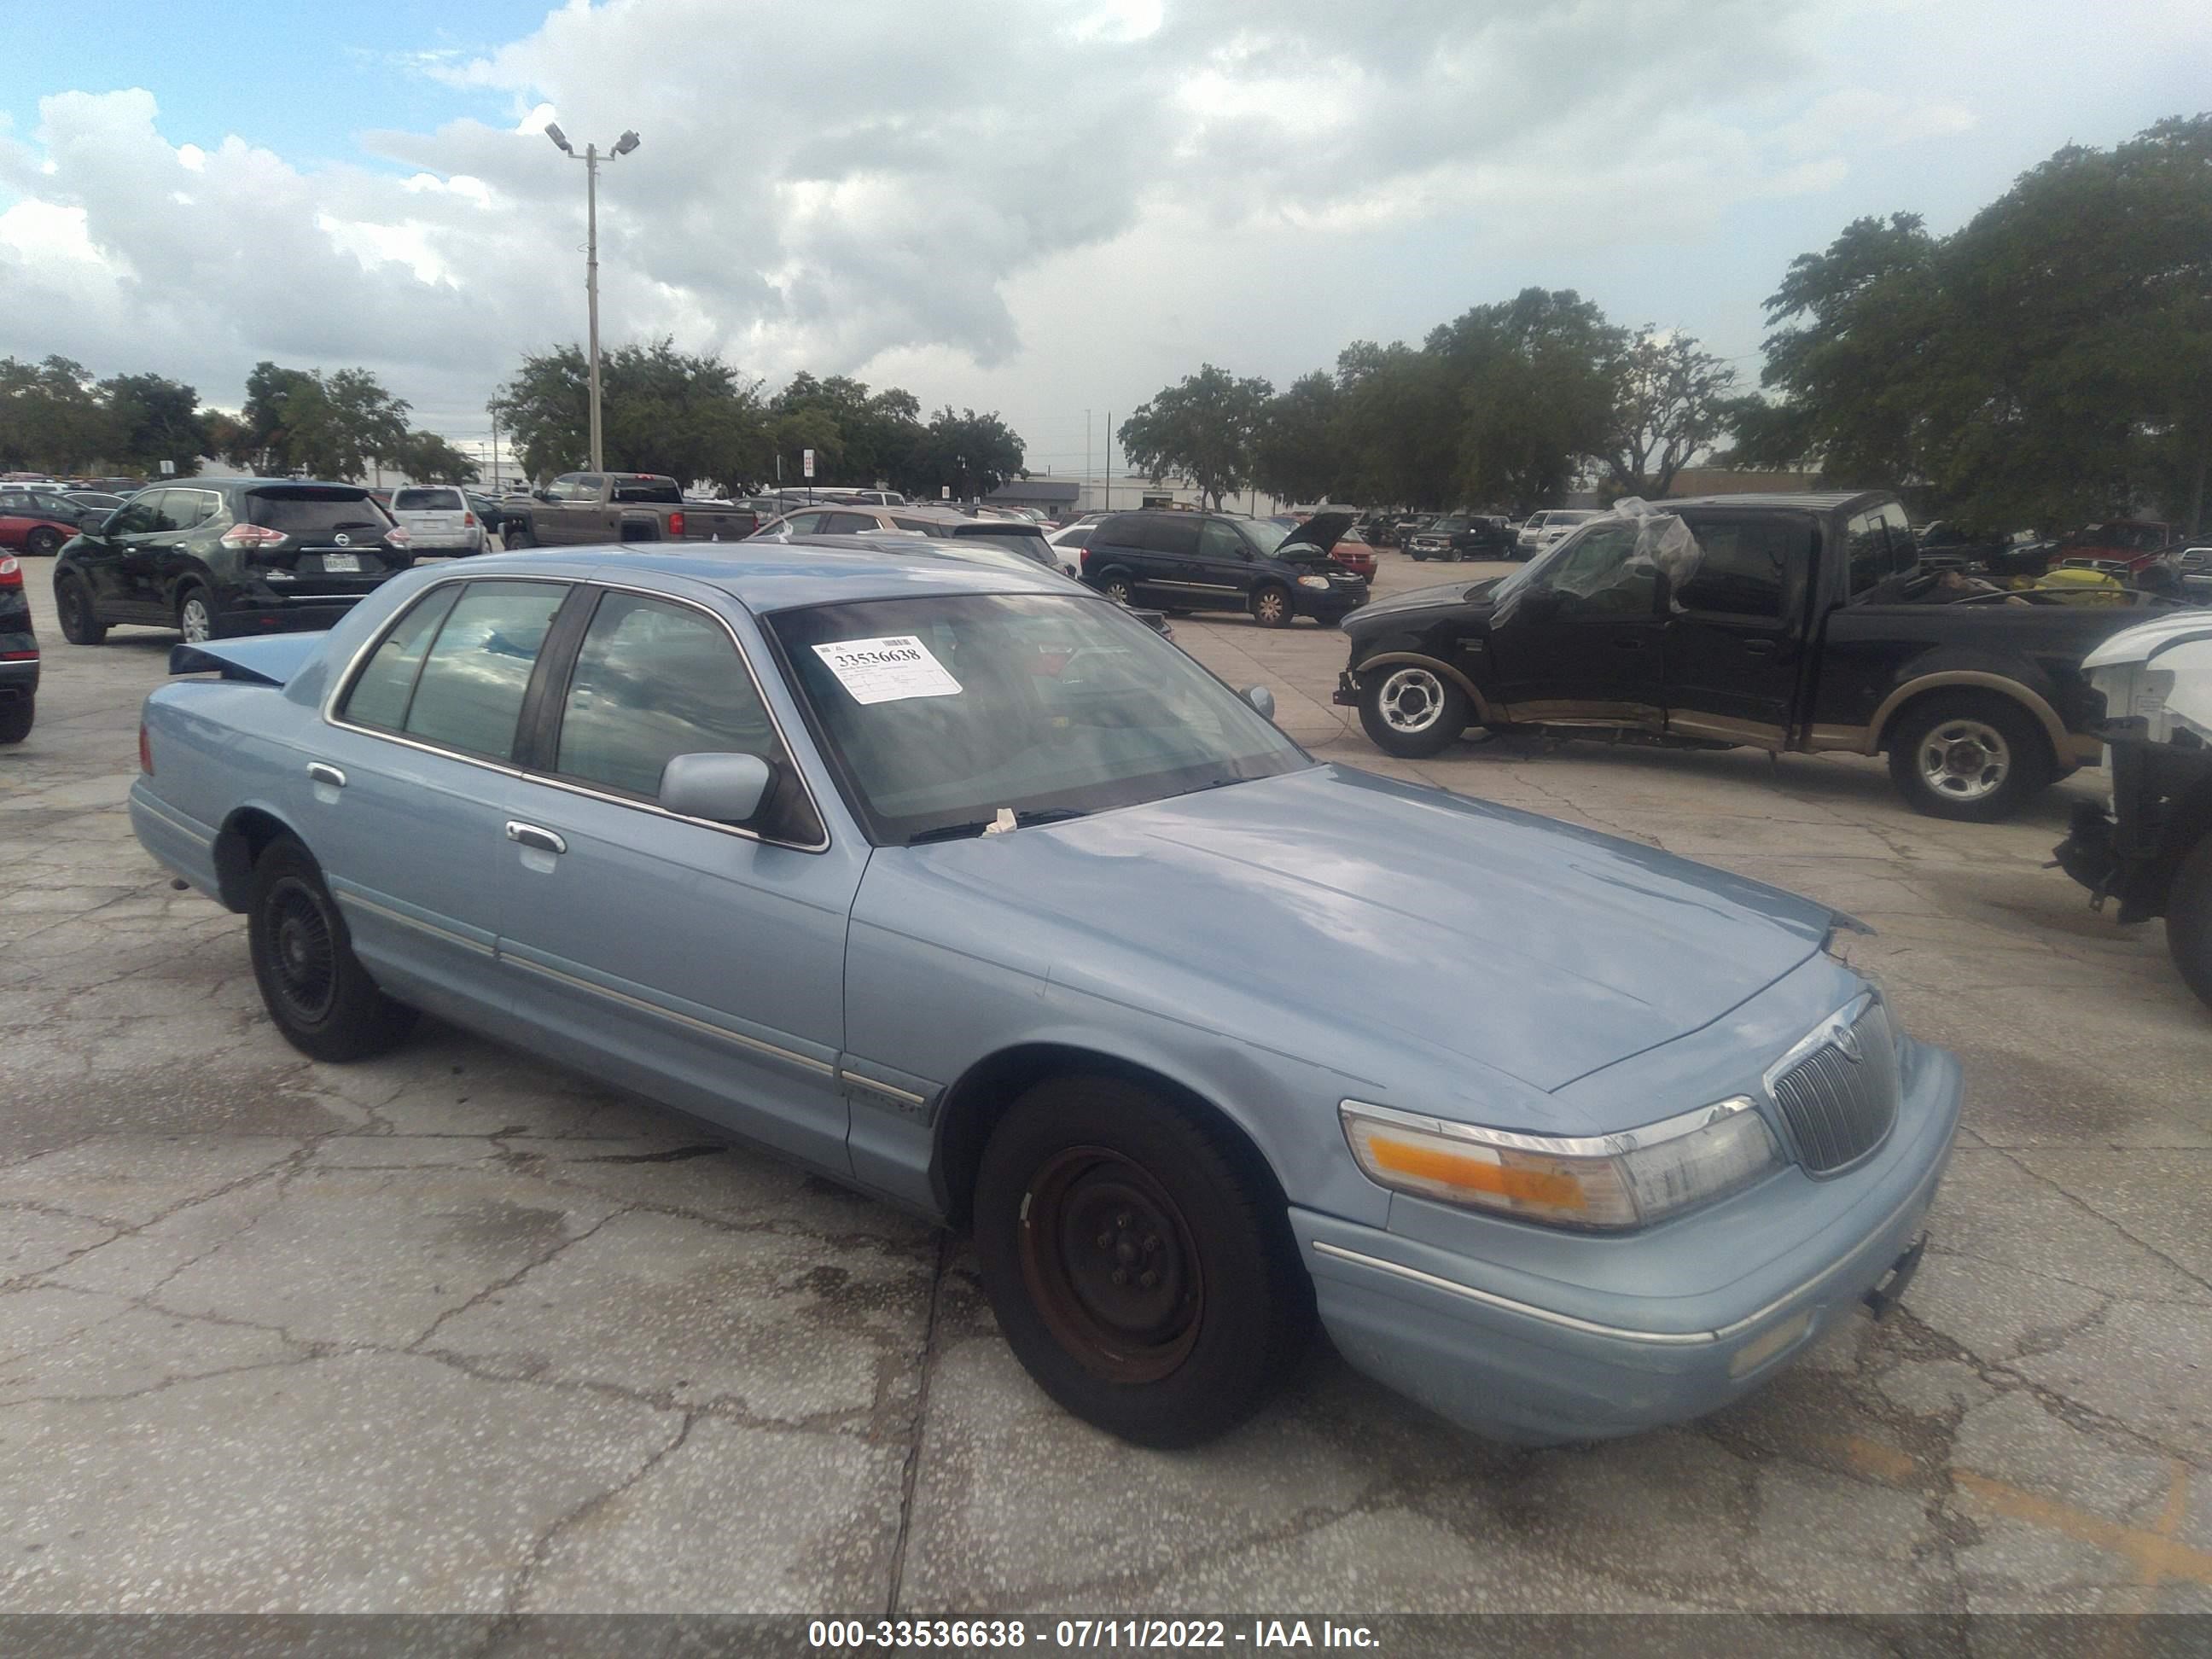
[1084,513,1367,628]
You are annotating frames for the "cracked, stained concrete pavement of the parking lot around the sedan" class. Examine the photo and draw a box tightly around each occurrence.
[0,553,2212,1613]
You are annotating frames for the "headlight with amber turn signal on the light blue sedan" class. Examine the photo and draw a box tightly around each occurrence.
[1338,1095,1781,1230]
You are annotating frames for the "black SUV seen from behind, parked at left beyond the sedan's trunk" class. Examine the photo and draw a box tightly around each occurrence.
[53,478,414,646]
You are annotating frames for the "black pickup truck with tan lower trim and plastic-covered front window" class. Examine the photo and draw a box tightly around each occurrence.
[1336,491,2161,823]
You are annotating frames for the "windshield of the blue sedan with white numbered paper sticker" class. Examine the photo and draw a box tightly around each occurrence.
[767,593,1312,845]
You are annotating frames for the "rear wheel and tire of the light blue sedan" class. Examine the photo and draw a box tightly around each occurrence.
[246,836,416,1060]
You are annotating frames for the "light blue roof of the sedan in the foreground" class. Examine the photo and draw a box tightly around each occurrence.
[469,535,1073,615]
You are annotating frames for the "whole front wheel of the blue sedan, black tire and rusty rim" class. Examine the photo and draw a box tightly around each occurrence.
[975,1077,1314,1447]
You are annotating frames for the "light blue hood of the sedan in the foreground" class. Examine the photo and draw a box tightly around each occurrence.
[896,765,1841,1106]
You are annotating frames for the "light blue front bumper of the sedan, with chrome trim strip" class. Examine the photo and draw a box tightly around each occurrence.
[1289,1039,1960,1445]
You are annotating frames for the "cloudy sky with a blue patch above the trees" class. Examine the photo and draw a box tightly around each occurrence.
[0,0,2212,471]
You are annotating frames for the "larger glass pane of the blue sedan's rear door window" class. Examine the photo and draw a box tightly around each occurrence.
[400,582,568,761]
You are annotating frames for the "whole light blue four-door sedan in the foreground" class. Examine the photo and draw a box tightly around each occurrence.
[131,544,1960,1447]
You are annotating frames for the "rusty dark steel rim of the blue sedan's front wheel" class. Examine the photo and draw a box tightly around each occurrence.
[1020,1146,1206,1382]
